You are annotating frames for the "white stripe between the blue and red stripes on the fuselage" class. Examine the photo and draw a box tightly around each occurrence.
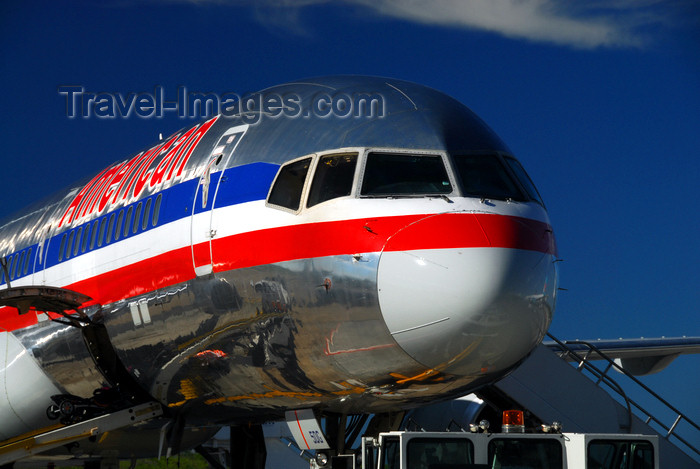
[12,197,548,294]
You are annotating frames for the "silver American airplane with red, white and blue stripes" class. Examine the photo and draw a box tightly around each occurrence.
[0,76,558,468]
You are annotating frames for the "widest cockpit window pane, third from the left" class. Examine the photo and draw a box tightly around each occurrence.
[361,152,452,197]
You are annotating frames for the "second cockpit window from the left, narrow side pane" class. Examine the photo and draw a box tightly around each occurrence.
[306,153,357,207]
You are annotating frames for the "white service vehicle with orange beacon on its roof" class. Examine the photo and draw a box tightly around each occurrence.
[311,411,660,469]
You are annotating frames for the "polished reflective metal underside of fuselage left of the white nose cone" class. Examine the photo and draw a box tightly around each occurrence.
[91,254,460,420]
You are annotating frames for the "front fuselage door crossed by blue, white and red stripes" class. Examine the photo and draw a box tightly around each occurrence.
[191,124,248,277]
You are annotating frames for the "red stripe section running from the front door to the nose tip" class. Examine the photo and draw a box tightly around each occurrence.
[212,213,556,272]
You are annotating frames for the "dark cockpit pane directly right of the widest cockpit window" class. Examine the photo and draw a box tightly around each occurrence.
[454,155,527,201]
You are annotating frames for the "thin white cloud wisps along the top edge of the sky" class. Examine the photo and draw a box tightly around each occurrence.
[152,0,695,49]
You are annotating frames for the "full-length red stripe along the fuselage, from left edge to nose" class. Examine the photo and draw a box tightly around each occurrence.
[0,213,556,330]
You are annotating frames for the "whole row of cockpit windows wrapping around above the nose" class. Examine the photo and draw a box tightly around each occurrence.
[267,148,544,213]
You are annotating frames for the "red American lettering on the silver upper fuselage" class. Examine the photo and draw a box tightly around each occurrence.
[58,116,219,228]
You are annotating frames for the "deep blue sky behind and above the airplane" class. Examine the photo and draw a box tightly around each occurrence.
[0,0,700,442]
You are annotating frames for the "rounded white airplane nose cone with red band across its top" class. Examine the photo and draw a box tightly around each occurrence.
[377,213,556,376]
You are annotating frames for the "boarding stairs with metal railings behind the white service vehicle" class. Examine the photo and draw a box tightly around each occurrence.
[494,334,700,468]
